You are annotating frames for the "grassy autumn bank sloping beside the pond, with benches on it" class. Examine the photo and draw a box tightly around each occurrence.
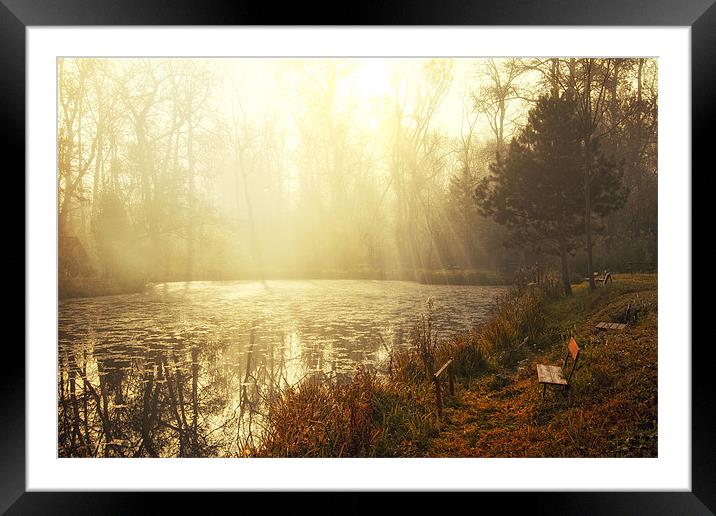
[256,275,657,457]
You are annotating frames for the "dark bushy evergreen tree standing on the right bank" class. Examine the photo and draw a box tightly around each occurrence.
[475,94,627,295]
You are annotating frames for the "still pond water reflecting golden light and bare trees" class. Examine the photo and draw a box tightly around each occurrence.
[58,280,506,457]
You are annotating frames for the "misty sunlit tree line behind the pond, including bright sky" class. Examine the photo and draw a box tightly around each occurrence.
[57,58,657,288]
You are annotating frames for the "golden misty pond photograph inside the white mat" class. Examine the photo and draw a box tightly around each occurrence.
[57,55,660,462]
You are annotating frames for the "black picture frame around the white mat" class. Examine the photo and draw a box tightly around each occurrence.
[0,0,716,514]
